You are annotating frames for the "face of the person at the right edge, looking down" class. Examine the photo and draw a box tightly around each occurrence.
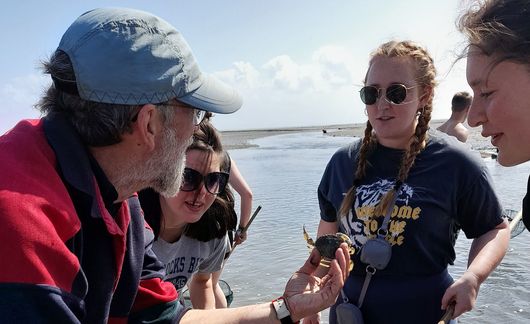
[467,47,530,166]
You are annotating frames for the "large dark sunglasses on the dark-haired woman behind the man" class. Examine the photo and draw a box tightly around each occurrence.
[180,168,228,195]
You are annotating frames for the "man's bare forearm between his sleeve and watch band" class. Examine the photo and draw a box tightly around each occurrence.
[180,303,280,324]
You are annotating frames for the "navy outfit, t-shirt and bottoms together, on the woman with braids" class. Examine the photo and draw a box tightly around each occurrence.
[318,132,502,324]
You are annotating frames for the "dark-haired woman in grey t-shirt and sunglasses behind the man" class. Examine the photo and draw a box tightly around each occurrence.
[139,122,231,309]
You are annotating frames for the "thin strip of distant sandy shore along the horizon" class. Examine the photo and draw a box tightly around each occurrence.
[220,120,495,156]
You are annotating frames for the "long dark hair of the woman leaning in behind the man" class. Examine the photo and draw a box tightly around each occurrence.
[138,121,235,242]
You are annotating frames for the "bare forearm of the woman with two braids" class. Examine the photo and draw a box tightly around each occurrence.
[467,221,510,284]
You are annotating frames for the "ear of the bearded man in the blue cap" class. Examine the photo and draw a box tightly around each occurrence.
[133,104,162,150]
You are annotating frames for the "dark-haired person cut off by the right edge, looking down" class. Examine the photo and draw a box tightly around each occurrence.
[459,0,530,230]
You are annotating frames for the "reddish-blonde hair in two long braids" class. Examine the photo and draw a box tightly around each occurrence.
[339,41,436,217]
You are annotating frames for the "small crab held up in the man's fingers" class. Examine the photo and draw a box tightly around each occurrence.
[303,226,355,270]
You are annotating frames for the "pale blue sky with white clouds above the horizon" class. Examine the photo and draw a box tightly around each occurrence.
[0,0,469,133]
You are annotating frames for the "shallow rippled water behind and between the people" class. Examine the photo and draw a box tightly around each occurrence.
[222,132,530,323]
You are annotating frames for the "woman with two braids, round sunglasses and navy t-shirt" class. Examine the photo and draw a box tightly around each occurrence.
[312,41,509,324]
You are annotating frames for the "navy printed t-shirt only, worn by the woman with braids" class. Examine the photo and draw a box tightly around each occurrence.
[318,132,502,275]
